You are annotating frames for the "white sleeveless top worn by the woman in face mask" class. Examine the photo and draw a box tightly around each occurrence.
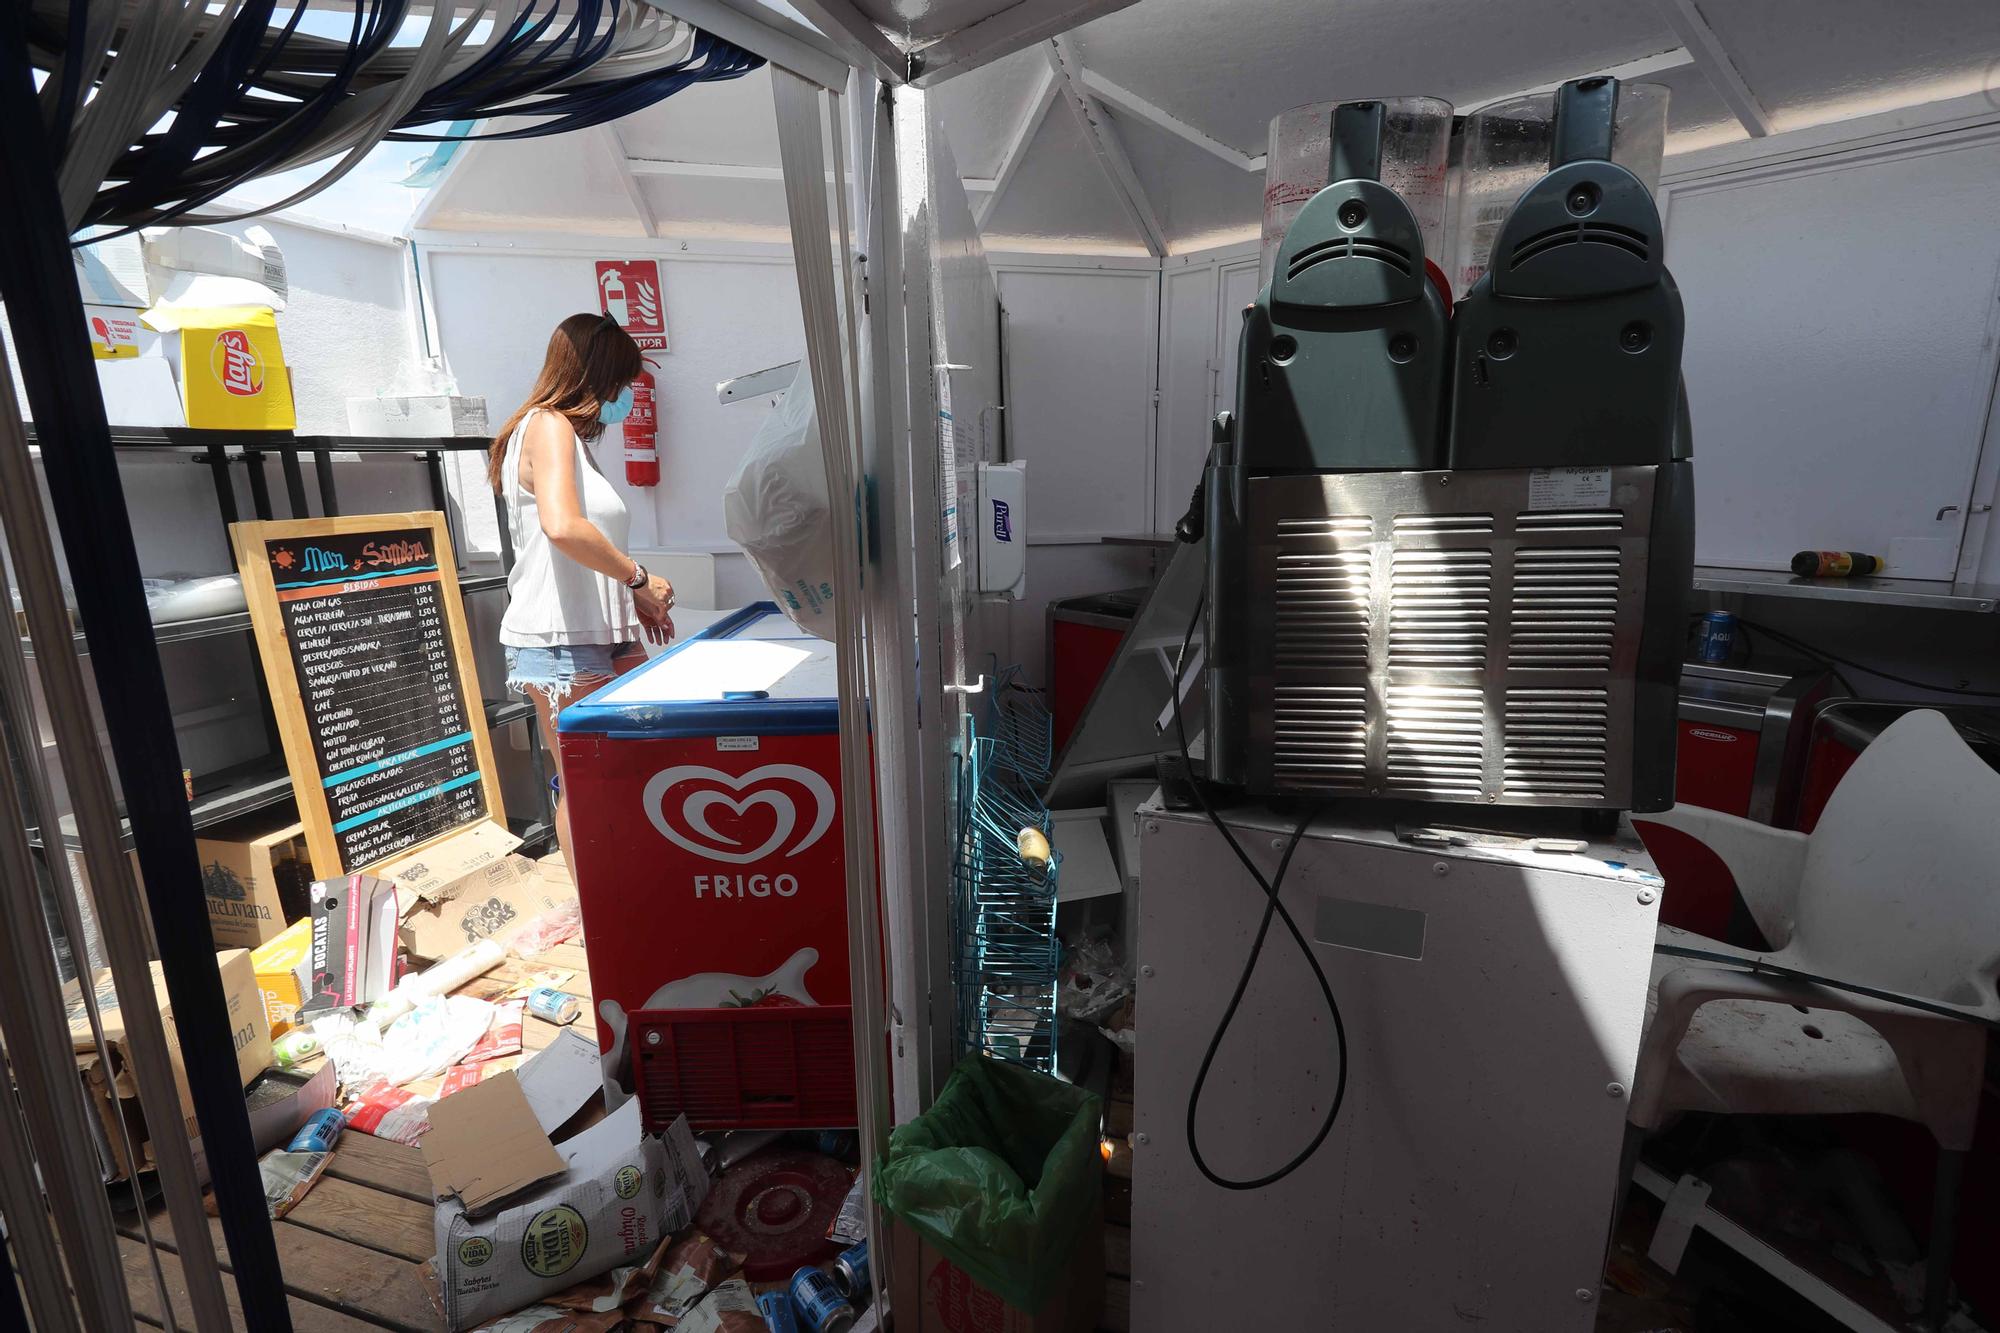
[500,408,642,648]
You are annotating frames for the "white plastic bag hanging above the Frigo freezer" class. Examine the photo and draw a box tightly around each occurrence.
[722,364,834,640]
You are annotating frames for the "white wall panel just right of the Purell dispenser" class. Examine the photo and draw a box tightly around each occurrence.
[994,262,1160,540]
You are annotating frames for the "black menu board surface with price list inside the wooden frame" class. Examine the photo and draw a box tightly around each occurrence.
[266,528,486,871]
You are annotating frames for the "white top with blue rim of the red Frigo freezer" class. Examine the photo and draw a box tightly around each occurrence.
[556,602,840,737]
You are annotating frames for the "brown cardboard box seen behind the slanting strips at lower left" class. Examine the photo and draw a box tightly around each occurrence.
[62,949,270,1179]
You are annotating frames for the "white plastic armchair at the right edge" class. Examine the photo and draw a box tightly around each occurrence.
[1620,711,2000,1327]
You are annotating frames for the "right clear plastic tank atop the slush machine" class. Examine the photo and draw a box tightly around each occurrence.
[1440,84,1668,296]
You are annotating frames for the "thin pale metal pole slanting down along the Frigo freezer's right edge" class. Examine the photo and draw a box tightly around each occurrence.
[772,70,894,1291]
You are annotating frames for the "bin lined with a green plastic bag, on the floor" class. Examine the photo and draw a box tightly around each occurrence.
[874,1055,1104,1333]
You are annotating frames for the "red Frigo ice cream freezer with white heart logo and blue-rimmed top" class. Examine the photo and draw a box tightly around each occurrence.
[556,602,856,1131]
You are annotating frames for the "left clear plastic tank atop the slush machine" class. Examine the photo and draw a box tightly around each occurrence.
[1260,98,1452,284]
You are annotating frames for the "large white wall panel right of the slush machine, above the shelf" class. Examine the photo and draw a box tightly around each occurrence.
[1668,128,2000,578]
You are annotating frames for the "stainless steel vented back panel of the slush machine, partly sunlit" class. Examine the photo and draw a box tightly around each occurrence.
[1248,468,1654,807]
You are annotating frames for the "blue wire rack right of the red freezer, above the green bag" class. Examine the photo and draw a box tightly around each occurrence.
[952,711,1062,1071]
